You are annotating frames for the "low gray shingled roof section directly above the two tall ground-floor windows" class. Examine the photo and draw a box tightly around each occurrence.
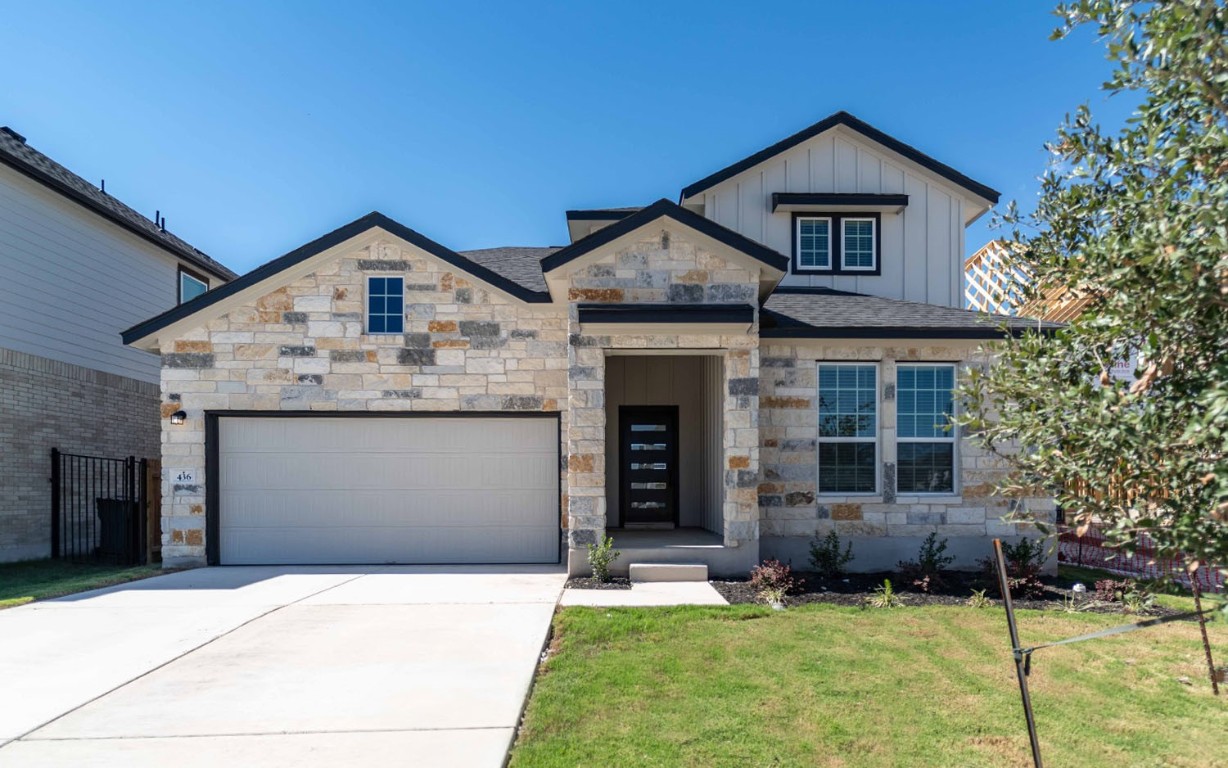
[759,288,1062,339]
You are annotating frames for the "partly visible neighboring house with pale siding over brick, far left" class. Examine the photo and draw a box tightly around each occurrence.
[0,128,236,562]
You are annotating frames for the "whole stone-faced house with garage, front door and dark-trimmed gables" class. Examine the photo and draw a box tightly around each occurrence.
[124,112,1052,573]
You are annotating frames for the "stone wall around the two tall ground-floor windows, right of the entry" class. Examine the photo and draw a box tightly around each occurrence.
[759,342,1055,570]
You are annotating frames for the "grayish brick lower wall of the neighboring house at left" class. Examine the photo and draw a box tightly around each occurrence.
[0,349,158,562]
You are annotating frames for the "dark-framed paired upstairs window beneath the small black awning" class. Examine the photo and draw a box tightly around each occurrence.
[793,213,882,275]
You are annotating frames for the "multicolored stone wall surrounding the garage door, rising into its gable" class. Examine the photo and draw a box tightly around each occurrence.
[154,242,567,564]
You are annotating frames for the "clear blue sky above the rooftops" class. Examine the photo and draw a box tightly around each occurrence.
[0,0,1127,272]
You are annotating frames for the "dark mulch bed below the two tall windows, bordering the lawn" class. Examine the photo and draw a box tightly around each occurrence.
[711,571,1178,616]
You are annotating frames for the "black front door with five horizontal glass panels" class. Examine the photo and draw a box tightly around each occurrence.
[619,406,678,528]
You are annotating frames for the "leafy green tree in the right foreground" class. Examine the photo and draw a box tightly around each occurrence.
[964,0,1228,575]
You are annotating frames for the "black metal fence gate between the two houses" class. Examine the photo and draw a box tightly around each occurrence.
[52,449,147,565]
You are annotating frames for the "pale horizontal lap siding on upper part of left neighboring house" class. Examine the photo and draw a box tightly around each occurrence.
[0,166,211,383]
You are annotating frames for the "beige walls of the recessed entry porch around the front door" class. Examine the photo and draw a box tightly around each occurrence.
[605,355,723,533]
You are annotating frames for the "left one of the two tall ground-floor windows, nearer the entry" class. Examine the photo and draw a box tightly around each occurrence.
[818,362,878,494]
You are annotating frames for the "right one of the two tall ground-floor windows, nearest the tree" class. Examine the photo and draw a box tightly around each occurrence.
[895,364,955,494]
